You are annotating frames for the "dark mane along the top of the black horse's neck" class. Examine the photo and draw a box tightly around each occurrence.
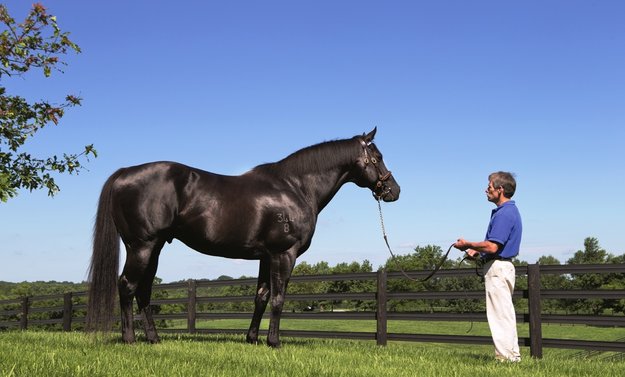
[252,136,358,175]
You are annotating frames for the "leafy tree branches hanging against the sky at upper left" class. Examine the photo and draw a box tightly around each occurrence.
[0,4,97,202]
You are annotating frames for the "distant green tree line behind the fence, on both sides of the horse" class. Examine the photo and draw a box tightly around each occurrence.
[0,237,625,326]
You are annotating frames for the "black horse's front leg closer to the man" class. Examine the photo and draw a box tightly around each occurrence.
[267,250,297,348]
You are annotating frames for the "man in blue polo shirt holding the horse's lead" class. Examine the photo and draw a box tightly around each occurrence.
[454,172,523,362]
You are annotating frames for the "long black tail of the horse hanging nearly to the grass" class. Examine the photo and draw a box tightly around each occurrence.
[86,170,121,331]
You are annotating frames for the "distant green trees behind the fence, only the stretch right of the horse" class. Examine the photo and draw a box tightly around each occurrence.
[282,237,625,315]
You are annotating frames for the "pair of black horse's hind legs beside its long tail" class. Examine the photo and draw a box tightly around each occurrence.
[118,243,163,343]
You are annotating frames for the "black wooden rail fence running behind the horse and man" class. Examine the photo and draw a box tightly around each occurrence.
[0,264,625,358]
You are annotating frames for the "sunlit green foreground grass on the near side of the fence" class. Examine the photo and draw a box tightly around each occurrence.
[0,331,625,377]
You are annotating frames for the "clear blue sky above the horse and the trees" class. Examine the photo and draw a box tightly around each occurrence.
[0,0,625,282]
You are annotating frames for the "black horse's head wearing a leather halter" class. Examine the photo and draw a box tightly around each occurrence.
[355,127,400,202]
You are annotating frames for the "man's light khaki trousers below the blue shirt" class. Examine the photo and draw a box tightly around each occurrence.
[484,260,521,361]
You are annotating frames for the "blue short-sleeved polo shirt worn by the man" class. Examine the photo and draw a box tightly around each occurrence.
[486,200,523,258]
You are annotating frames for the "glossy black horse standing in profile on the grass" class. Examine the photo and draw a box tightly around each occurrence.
[87,129,400,347]
